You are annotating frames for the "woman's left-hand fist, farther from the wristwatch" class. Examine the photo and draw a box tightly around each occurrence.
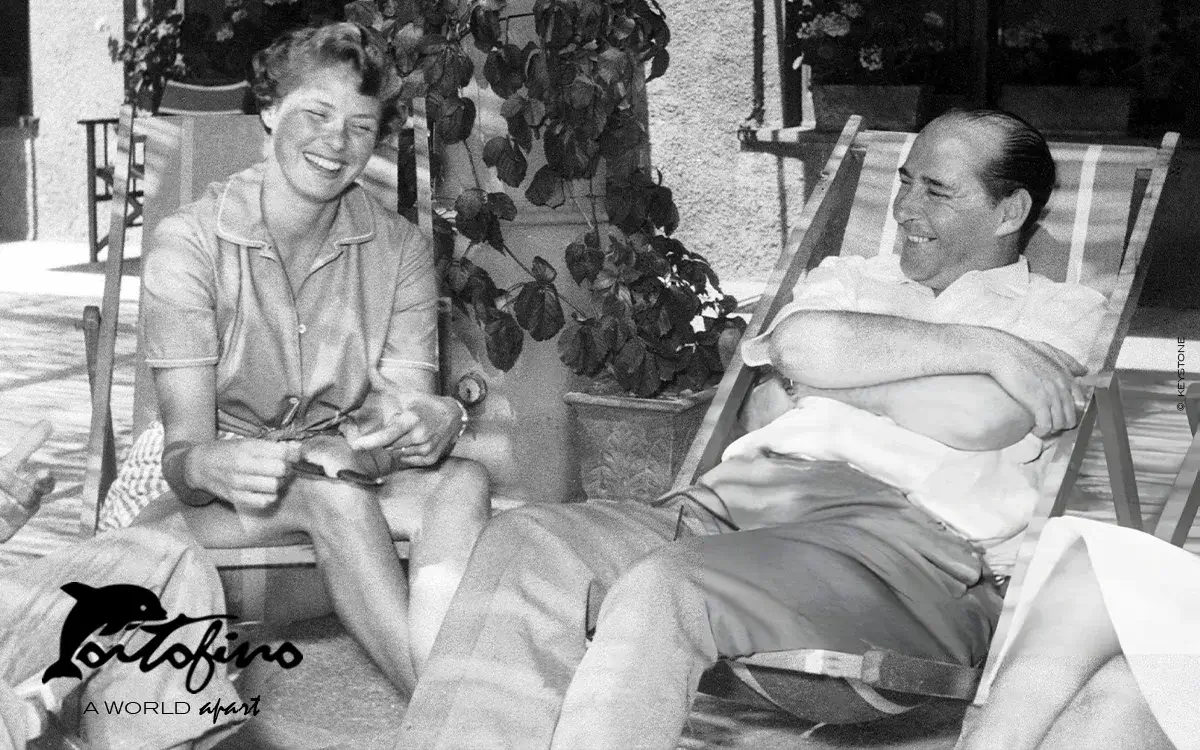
[184,438,300,509]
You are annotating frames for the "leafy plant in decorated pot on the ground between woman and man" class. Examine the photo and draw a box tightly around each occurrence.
[558,184,745,502]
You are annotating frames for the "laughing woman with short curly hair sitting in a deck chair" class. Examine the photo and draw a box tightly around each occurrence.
[110,23,488,686]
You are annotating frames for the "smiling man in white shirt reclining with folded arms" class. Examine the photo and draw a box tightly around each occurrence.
[402,110,1104,749]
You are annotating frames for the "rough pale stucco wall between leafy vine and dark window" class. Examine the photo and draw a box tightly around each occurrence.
[647,0,804,288]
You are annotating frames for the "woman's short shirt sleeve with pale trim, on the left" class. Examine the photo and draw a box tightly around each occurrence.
[140,214,220,367]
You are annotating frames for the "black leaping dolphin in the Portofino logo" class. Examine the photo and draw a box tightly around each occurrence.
[42,582,167,683]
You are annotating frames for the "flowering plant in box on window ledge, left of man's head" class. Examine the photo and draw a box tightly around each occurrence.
[788,0,946,131]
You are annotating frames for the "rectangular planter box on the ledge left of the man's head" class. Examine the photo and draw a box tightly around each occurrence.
[812,83,931,132]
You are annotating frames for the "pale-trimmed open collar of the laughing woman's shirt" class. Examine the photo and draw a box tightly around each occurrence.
[216,162,374,247]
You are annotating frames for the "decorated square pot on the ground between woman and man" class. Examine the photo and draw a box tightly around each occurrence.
[563,388,716,503]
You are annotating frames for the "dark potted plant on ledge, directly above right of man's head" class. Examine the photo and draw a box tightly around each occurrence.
[1000,19,1140,133]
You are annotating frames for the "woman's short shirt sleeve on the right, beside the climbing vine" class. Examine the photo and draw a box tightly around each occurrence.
[379,220,438,377]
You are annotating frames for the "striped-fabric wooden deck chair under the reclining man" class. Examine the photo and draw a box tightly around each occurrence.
[673,116,1180,712]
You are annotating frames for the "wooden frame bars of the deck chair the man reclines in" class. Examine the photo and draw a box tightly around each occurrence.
[672,115,1185,712]
